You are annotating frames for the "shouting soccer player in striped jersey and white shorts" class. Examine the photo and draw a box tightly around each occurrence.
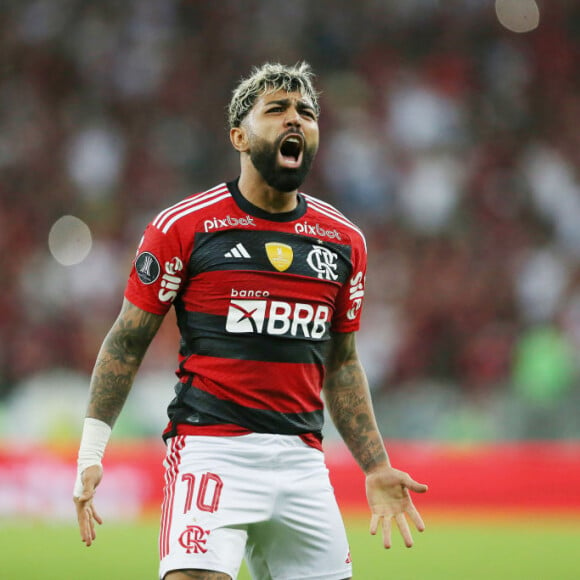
[74,63,427,580]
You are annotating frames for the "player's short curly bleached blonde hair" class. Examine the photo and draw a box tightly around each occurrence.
[228,61,320,128]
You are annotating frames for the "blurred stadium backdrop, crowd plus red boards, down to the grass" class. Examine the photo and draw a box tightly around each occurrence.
[0,0,580,576]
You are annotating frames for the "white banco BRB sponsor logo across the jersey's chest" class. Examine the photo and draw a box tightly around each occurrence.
[226,289,330,339]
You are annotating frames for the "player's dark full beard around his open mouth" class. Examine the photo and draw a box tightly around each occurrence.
[250,135,316,193]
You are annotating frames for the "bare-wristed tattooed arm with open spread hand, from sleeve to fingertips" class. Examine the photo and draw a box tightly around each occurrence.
[324,333,427,548]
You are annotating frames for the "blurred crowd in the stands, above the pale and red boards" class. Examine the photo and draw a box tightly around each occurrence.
[0,0,580,436]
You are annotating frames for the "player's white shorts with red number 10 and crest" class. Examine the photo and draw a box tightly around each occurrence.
[159,433,352,580]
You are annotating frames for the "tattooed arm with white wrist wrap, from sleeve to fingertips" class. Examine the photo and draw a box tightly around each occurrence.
[74,300,163,546]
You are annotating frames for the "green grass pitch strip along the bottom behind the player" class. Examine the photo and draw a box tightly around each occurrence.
[0,514,580,580]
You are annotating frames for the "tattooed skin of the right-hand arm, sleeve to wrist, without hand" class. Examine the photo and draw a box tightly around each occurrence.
[324,333,388,472]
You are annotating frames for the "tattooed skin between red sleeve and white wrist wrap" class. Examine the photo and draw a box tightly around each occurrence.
[87,301,163,426]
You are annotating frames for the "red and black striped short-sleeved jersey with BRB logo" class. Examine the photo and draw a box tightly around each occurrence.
[125,182,366,447]
